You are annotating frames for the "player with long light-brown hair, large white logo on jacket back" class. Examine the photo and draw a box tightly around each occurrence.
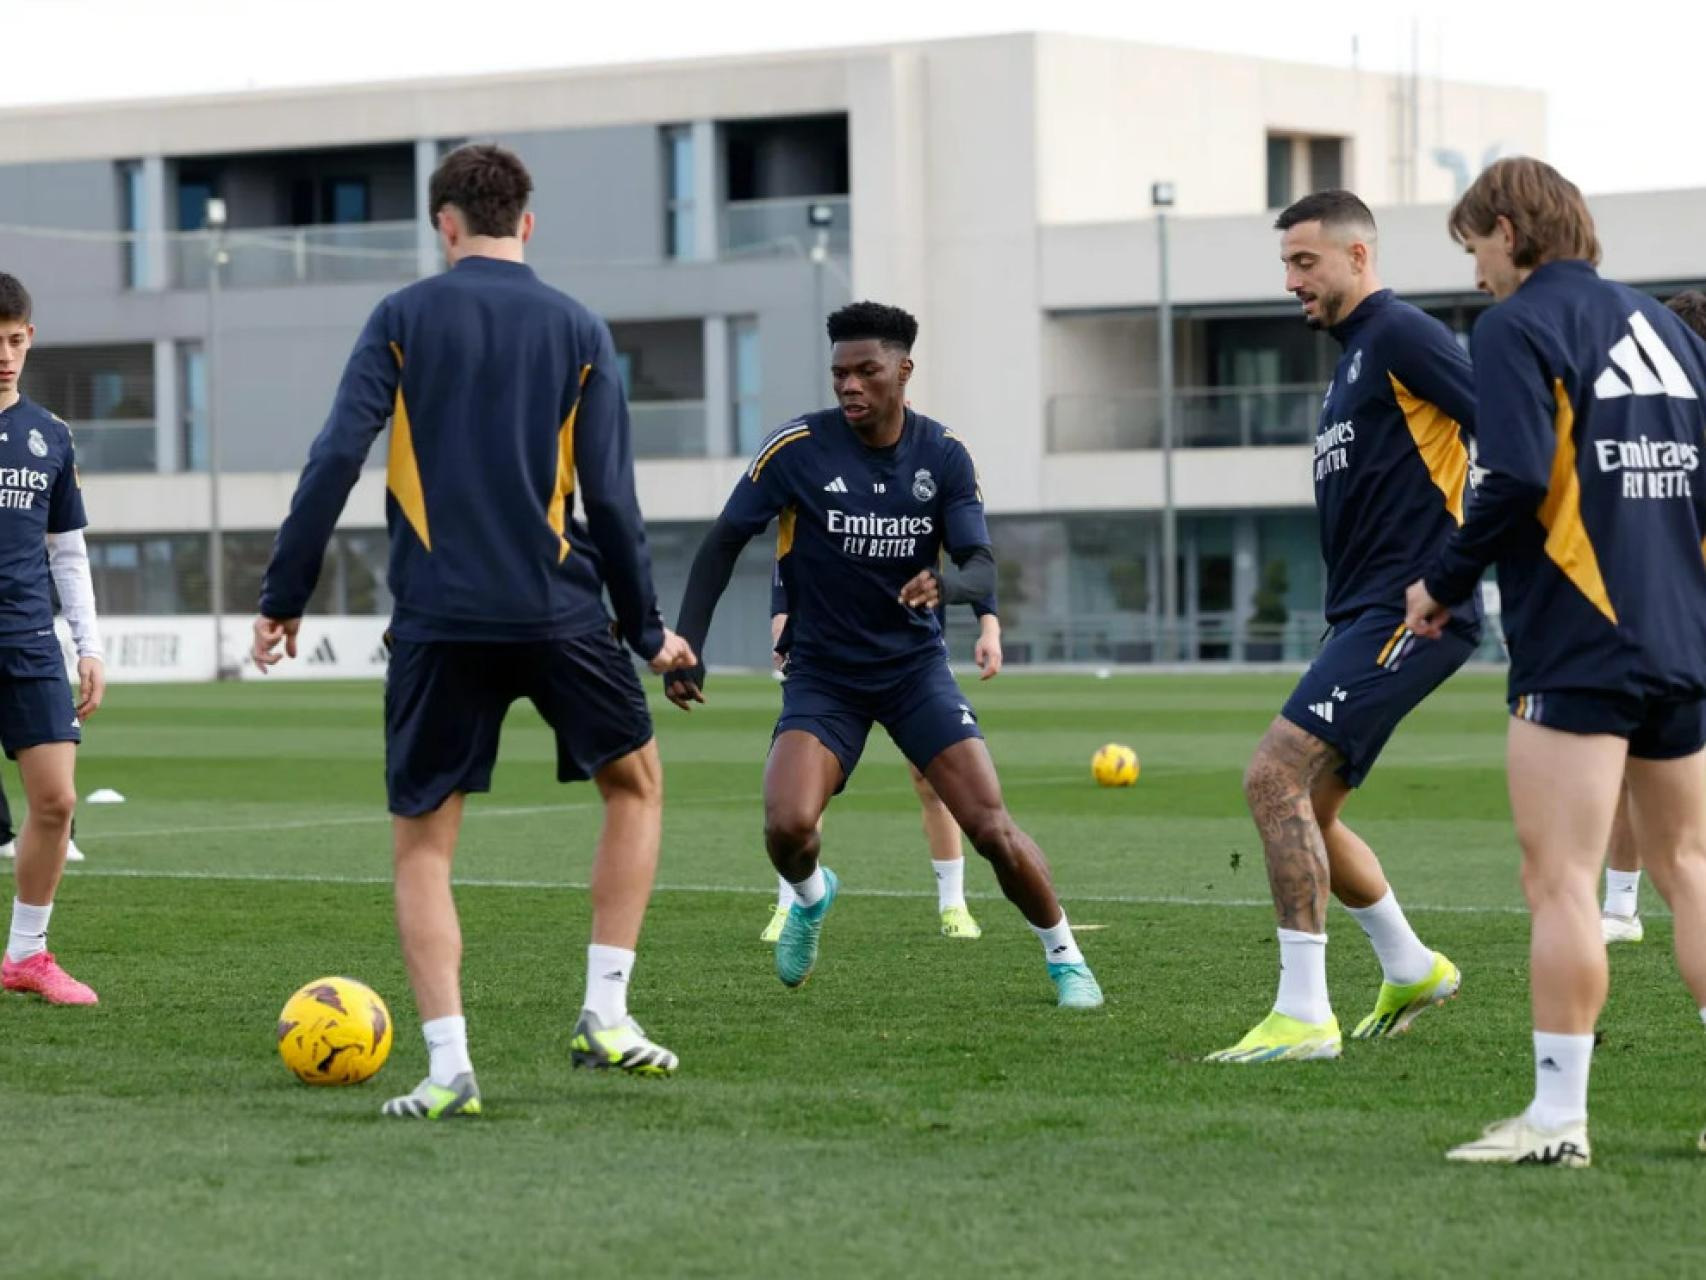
[1409,157,1706,1167]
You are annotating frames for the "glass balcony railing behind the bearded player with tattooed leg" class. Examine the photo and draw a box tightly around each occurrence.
[1049,384,1322,454]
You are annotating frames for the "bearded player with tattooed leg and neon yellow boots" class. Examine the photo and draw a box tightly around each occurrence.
[1210,191,1481,1063]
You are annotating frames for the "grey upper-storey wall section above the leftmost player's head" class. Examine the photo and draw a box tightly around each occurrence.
[0,160,125,298]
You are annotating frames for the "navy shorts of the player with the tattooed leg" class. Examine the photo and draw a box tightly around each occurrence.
[1280,609,1481,787]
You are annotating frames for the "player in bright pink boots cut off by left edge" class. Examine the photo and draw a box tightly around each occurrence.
[0,273,106,1005]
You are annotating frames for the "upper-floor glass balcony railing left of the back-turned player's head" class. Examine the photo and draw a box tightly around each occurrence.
[169,222,416,288]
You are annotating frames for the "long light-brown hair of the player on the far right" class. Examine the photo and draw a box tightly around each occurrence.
[1447,155,1599,266]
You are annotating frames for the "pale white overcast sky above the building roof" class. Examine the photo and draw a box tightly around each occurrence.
[16,0,1706,191]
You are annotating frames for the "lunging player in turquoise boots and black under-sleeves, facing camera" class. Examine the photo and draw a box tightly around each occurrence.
[665,302,1102,1009]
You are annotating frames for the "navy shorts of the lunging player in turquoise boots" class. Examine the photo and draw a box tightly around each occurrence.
[771,659,983,790]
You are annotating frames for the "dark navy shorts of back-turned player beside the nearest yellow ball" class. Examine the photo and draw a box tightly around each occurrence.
[386,628,652,817]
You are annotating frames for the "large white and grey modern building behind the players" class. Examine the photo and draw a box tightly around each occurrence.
[10,34,1665,664]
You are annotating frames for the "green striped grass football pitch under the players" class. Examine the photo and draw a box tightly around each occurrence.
[0,676,1706,1277]
